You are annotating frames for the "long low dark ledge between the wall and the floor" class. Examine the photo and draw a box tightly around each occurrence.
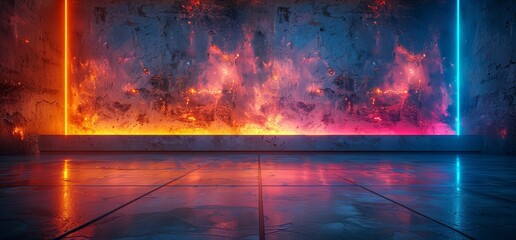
[39,135,483,152]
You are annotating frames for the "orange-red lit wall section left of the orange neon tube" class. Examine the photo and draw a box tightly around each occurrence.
[0,0,63,153]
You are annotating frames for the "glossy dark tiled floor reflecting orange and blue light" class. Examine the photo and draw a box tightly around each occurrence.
[0,153,516,239]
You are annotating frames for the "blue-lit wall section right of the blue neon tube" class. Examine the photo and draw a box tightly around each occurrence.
[462,0,516,154]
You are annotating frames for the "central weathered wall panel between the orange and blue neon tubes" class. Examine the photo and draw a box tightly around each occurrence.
[69,0,455,135]
